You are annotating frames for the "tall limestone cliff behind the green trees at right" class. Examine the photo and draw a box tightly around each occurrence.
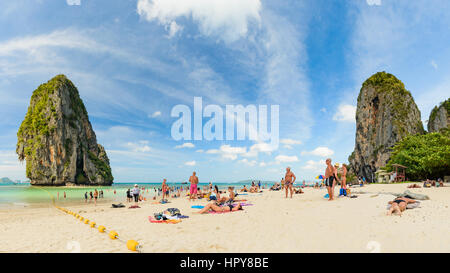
[349,72,424,182]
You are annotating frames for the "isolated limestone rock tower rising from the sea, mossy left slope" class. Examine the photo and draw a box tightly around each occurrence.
[16,75,114,186]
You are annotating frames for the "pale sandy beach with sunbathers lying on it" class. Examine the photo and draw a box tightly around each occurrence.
[0,184,450,253]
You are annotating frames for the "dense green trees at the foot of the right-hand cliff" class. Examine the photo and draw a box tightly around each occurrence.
[386,129,450,180]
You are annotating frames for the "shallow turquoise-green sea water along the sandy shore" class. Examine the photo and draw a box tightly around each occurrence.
[0,183,278,208]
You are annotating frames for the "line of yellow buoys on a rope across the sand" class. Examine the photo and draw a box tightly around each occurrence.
[36,186,142,253]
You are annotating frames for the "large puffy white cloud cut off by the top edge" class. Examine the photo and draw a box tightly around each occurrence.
[137,0,261,41]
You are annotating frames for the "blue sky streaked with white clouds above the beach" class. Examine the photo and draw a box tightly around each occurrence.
[0,0,450,182]
